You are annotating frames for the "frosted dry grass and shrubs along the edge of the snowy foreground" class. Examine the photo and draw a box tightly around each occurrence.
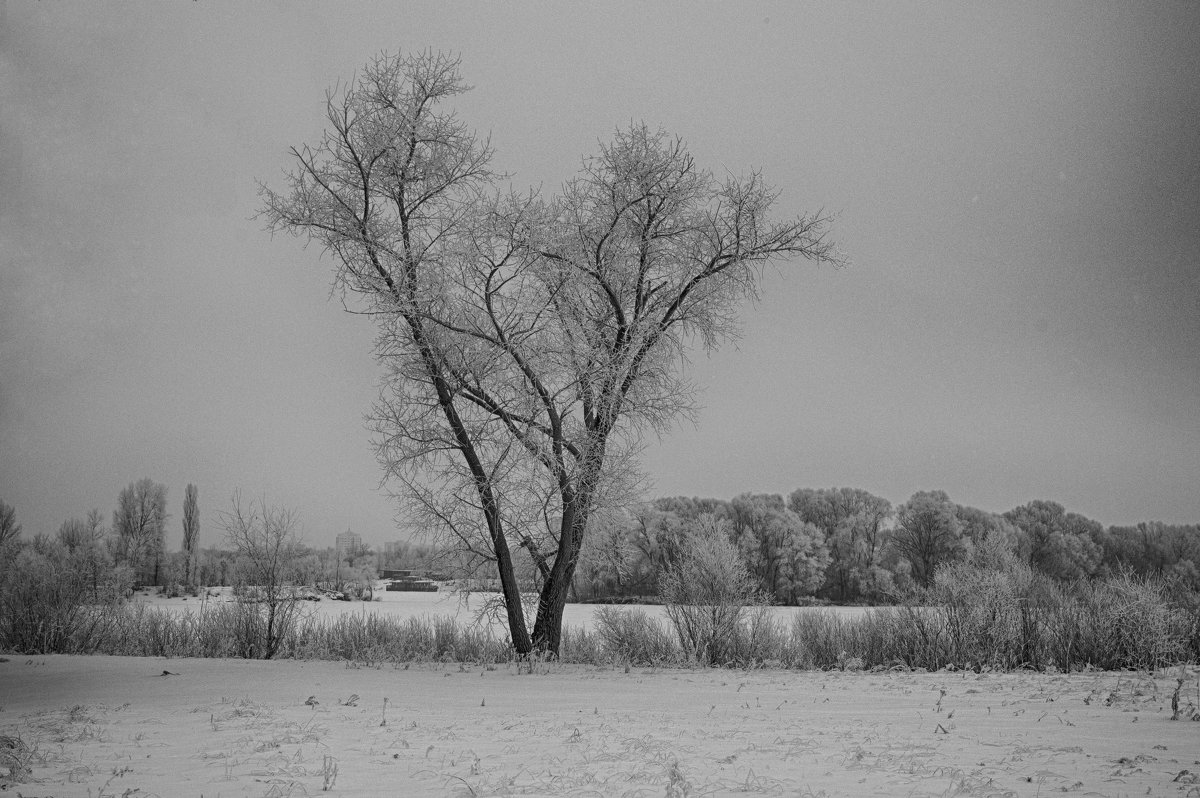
[0,566,1200,671]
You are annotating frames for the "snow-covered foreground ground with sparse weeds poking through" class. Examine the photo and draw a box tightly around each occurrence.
[0,655,1200,798]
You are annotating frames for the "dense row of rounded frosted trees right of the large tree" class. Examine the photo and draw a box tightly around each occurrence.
[575,488,1200,604]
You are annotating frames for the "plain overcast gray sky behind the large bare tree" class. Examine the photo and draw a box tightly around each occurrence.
[0,1,1200,545]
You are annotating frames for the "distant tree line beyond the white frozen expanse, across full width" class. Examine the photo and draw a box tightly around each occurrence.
[0,479,1200,605]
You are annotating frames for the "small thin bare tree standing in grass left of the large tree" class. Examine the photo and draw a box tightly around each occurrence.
[220,493,302,660]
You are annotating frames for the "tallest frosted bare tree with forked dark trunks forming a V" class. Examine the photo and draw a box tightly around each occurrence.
[262,53,838,654]
